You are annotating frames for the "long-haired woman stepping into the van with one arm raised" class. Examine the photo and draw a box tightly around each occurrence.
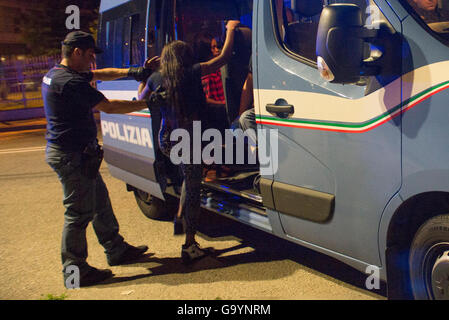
[159,21,239,263]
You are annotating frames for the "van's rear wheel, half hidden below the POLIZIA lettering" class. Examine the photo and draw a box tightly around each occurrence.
[134,190,176,220]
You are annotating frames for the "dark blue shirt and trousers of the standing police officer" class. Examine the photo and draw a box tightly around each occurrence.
[42,65,129,278]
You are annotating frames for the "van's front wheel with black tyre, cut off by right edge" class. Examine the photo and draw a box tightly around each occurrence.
[409,214,449,300]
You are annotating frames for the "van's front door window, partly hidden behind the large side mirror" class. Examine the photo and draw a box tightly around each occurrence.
[272,0,369,64]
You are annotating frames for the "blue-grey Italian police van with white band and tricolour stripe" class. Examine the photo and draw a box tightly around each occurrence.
[97,0,449,299]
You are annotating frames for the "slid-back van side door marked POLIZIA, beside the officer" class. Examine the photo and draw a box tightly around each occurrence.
[97,0,174,218]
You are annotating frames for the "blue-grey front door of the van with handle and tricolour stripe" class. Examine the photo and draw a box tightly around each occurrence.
[253,0,401,265]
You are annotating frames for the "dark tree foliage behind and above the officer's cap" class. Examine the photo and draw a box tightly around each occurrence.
[21,0,100,56]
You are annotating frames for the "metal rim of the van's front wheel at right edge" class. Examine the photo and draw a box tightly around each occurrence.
[422,242,449,299]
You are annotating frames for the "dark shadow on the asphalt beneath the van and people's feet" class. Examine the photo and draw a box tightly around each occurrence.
[97,212,386,296]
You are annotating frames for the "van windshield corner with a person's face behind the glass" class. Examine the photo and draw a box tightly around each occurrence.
[406,0,449,41]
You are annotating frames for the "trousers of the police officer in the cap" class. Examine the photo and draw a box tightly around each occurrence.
[46,145,127,276]
